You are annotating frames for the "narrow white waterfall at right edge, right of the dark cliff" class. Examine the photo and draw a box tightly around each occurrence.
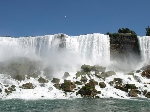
[138,36,150,61]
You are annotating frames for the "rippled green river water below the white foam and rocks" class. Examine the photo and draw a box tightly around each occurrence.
[0,99,150,112]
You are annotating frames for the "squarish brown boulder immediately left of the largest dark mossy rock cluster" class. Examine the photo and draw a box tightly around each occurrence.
[61,80,76,92]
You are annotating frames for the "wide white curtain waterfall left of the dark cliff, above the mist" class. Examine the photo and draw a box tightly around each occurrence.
[0,33,110,66]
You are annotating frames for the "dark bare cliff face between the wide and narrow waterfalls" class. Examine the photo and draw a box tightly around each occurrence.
[110,34,140,60]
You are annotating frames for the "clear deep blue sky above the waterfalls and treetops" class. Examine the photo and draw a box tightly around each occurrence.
[0,0,150,37]
